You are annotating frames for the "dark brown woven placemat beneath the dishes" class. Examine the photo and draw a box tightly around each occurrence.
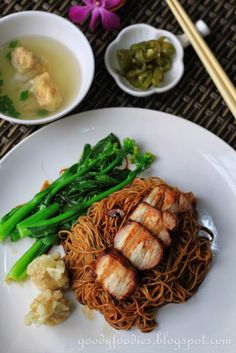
[0,0,236,158]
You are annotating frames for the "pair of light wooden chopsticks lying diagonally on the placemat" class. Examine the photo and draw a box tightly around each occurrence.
[166,0,236,118]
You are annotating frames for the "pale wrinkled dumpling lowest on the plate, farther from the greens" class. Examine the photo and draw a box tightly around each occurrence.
[24,289,71,326]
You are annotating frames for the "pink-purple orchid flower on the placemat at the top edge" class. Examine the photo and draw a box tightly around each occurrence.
[69,0,122,31]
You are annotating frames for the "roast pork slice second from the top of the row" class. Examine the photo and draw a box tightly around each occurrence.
[130,202,177,246]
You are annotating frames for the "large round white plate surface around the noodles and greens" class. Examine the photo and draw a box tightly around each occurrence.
[0,108,236,353]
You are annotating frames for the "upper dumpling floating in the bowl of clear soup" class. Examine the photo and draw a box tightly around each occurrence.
[11,47,48,76]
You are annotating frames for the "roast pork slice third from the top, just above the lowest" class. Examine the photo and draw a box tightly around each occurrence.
[114,221,163,270]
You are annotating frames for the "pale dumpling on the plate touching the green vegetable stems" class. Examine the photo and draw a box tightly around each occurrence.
[27,253,69,290]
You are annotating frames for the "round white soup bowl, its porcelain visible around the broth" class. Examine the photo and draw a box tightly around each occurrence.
[0,11,95,125]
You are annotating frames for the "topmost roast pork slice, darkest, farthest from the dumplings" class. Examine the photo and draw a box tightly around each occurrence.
[144,184,195,214]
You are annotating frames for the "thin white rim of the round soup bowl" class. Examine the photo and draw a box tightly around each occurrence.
[0,10,95,125]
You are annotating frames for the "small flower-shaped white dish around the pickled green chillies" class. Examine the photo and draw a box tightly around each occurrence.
[105,23,184,97]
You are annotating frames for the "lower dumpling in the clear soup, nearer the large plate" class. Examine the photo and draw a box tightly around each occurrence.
[30,72,62,112]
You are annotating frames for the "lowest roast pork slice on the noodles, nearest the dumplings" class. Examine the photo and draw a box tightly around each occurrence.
[94,250,137,300]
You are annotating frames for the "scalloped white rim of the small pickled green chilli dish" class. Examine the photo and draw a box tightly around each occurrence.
[104,23,184,97]
